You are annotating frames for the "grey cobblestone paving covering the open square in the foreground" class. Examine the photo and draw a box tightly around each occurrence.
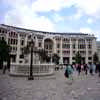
[0,71,100,100]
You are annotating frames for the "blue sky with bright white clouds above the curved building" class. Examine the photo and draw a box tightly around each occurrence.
[0,0,100,40]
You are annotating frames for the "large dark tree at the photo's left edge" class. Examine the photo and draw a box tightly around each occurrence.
[0,40,10,68]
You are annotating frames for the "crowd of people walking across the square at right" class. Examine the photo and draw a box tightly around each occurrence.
[64,63,100,80]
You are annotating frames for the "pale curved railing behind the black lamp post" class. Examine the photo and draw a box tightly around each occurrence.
[10,64,55,75]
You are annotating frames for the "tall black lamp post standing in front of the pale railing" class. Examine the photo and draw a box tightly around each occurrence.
[28,40,34,80]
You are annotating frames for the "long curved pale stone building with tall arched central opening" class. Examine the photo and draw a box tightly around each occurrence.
[0,24,97,64]
